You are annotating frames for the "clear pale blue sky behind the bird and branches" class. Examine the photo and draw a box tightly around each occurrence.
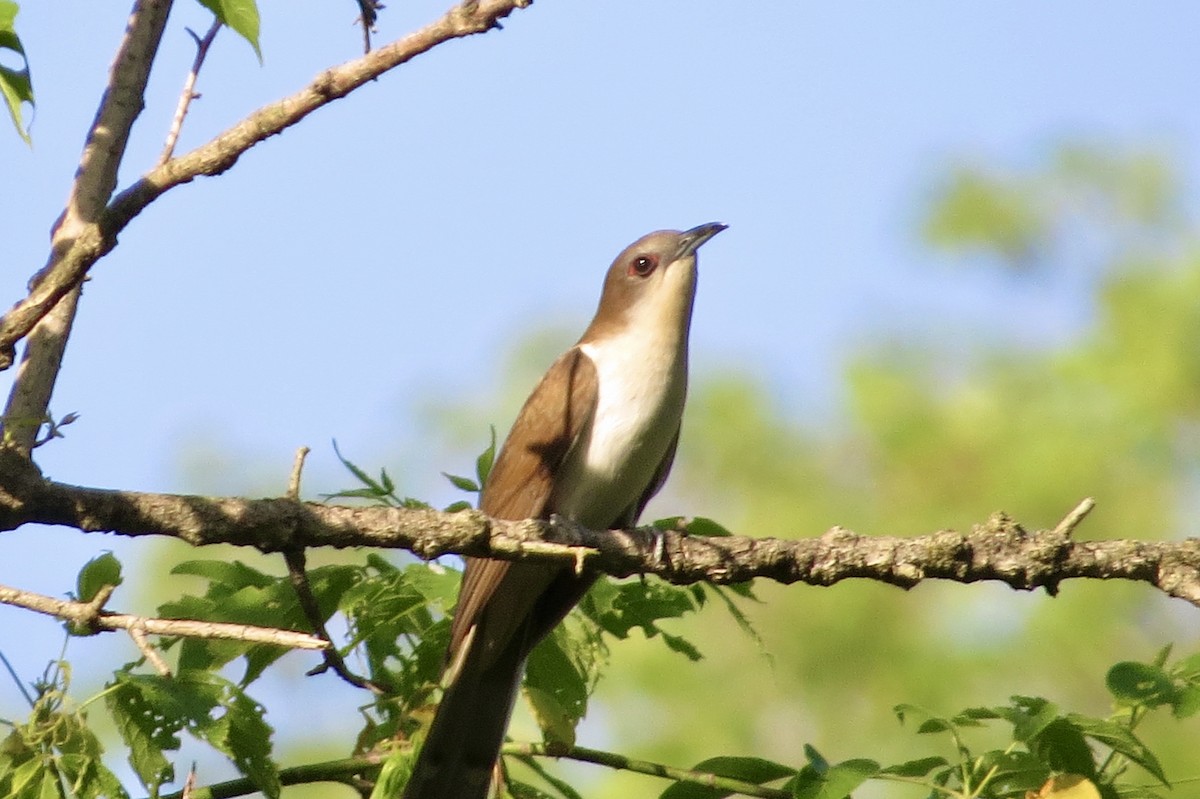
[0,0,1200,777]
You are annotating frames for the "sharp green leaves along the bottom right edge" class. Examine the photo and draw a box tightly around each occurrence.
[628,650,1200,799]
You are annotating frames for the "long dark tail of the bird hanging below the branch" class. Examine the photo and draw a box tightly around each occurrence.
[403,623,527,799]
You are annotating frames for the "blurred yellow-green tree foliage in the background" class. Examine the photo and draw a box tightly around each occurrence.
[124,145,1200,798]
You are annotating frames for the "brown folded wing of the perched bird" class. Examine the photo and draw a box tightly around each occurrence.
[448,347,596,660]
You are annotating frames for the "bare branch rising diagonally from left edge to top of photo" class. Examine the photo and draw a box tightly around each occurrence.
[0,0,530,374]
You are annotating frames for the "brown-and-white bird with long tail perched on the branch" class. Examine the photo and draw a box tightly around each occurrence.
[403,222,725,799]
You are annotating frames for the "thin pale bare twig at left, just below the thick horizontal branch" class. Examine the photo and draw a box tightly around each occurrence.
[0,585,329,649]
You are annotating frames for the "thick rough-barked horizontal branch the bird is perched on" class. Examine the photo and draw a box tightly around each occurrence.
[0,450,1200,606]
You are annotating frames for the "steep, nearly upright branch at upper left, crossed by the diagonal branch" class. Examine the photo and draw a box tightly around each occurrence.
[0,0,172,455]
